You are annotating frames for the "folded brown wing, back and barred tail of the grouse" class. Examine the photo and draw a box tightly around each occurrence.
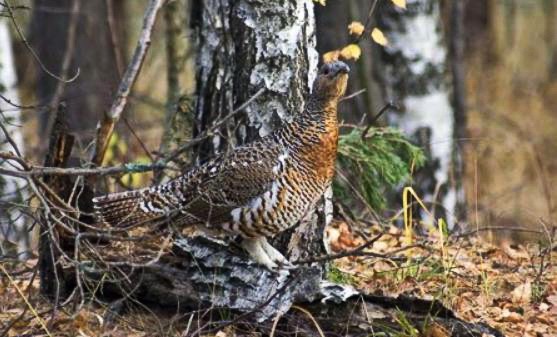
[93,142,284,227]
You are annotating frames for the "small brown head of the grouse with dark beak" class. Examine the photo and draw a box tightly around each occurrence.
[313,61,350,100]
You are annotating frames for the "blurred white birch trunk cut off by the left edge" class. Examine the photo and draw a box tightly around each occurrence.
[0,17,30,258]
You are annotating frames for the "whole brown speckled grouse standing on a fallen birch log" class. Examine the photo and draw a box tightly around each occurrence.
[93,61,350,270]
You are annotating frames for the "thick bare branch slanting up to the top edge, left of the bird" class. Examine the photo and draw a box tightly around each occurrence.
[92,0,163,166]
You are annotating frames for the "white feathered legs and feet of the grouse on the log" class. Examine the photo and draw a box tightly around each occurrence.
[242,237,294,271]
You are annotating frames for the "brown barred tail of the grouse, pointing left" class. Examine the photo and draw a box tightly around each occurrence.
[93,186,171,227]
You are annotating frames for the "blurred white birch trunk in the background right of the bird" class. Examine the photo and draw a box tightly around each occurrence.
[378,0,464,228]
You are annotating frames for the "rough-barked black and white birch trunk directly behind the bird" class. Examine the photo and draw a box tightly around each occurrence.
[189,0,326,259]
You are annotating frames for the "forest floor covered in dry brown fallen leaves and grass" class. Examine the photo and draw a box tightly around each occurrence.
[0,222,557,337]
